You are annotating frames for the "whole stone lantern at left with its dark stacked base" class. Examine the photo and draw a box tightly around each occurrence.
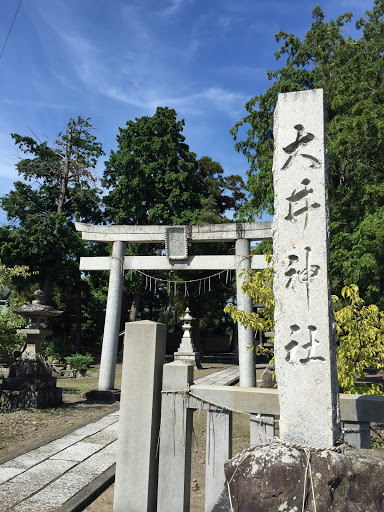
[0,290,62,409]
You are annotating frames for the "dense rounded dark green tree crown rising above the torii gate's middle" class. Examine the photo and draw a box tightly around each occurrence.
[102,107,203,224]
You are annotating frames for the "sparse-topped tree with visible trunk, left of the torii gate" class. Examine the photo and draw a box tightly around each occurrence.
[0,117,103,352]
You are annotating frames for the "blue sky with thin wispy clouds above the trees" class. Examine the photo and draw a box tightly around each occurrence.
[0,0,373,223]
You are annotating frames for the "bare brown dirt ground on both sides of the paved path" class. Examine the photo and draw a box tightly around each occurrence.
[0,364,249,512]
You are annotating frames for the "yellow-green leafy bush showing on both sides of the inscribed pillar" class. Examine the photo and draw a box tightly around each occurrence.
[224,254,384,395]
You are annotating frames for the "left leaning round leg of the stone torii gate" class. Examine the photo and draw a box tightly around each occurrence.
[98,242,127,391]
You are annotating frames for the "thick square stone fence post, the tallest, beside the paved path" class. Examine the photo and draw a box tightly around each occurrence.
[113,320,166,512]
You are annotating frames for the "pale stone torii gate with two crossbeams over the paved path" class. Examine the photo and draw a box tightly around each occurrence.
[76,218,272,391]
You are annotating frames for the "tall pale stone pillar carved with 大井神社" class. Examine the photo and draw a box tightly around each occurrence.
[273,89,340,447]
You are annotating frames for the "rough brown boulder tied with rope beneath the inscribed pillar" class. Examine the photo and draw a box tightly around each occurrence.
[224,442,384,512]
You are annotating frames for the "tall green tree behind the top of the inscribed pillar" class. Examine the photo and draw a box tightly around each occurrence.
[232,0,384,307]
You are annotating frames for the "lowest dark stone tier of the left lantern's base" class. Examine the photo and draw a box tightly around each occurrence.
[0,388,63,411]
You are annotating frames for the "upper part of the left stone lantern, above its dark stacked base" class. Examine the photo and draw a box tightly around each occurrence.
[12,290,63,359]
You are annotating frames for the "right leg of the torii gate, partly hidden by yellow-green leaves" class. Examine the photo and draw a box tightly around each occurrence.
[235,238,256,387]
